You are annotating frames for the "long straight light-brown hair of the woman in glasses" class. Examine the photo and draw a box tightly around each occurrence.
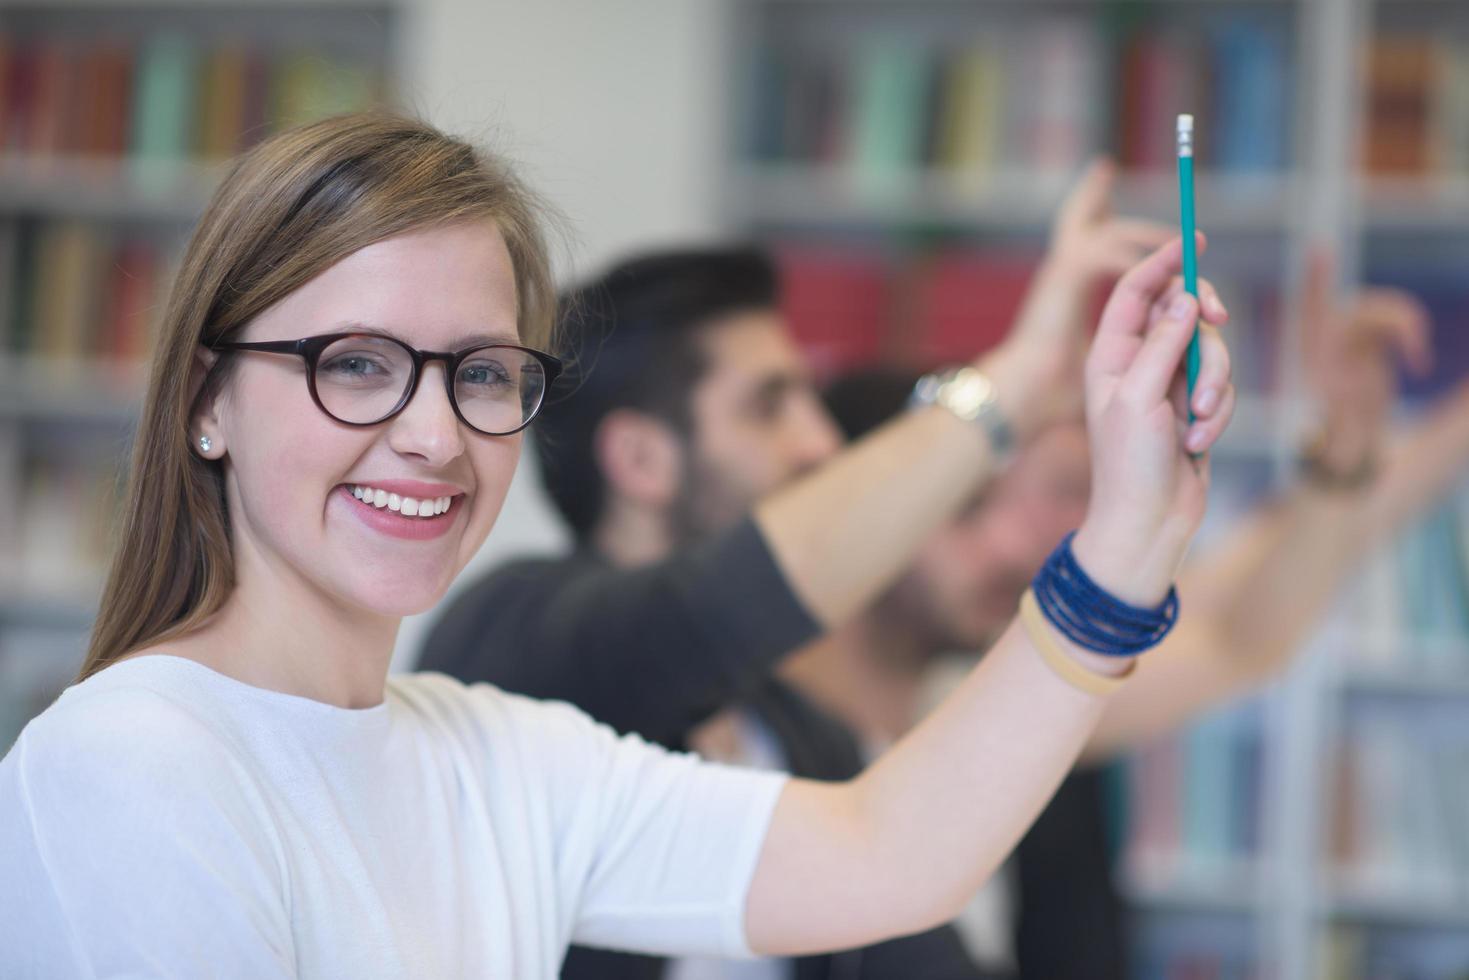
[78,112,555,680]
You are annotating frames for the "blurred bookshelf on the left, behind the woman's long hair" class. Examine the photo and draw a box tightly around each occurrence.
[0,0,401,751]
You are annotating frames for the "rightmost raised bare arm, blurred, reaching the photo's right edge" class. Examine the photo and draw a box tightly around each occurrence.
[1087,259,1469,757]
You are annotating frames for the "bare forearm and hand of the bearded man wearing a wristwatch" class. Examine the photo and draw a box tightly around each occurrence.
[755,160,1175,627]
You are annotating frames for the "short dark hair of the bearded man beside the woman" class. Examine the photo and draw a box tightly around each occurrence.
[535,245,779,539]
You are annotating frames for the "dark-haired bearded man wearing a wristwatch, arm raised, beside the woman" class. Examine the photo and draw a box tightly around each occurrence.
[419,163,1232,977]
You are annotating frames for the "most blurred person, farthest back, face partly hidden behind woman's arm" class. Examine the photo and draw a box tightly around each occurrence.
[793,256,1469,977]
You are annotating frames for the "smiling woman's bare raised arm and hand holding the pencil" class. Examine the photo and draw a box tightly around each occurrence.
[746,233,1234,954]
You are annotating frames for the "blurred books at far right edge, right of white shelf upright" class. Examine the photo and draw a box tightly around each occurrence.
[1316,0,1469,980]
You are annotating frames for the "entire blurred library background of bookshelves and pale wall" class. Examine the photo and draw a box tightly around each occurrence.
[0,0,1469,980]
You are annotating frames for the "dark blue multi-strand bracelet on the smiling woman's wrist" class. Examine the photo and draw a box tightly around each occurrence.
[1031,532,1178,657]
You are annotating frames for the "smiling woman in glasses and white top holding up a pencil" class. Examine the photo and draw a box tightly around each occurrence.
[0,115,1231,980]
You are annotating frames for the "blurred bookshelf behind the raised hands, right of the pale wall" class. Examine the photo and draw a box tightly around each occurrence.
[720,0,1469,980]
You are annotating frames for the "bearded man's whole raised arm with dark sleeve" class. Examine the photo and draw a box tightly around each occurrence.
[420,163,1192,742]
